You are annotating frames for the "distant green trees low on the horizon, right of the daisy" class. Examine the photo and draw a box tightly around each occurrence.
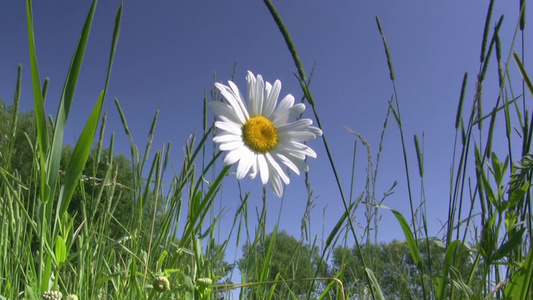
[332,239,473,299]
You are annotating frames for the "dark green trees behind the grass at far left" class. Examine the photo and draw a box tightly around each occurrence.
[0,104,143,238]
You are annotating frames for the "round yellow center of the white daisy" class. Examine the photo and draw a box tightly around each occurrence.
[242,116,278,153]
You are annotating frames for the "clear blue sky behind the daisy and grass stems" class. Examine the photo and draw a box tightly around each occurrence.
[0,0,533,253]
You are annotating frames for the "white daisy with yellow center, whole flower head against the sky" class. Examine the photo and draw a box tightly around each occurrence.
[209,71,322,197]
